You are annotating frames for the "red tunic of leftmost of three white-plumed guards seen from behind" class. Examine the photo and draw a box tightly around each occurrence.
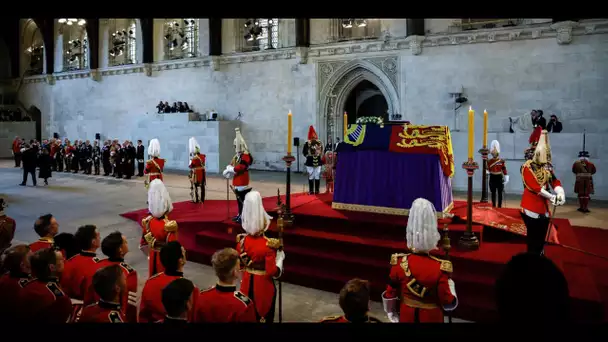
[141,215,177,277]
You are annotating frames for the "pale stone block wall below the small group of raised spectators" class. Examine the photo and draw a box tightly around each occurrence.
[131,113,240,173]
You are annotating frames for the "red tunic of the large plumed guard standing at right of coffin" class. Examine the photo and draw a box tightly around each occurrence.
[521,160,562,215]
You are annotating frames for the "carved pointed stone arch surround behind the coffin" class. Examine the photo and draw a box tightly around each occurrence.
[317,57,401,139]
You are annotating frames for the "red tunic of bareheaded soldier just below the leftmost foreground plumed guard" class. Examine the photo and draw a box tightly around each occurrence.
[139,271,198,323]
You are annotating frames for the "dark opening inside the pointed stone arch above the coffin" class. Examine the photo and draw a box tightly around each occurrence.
[344,80,389,124]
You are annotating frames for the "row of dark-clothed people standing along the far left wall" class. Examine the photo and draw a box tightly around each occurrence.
[12,137,145,186]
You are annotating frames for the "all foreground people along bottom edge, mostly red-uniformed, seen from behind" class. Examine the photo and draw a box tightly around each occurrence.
[0,179,570,324]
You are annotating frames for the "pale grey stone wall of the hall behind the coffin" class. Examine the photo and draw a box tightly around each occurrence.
[13,19,608,196]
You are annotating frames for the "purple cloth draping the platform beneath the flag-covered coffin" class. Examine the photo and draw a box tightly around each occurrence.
[333,150,452,212]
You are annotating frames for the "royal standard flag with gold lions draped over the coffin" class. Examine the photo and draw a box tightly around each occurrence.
[338,124,454,177]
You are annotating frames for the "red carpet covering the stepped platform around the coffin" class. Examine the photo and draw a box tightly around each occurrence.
[122,194,608,322]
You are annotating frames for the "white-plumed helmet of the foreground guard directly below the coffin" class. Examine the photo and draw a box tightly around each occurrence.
[406,198,441,252]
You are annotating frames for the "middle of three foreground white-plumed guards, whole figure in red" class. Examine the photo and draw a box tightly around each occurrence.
[236,191,285,323]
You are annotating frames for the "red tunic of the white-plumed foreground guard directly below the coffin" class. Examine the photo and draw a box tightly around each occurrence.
[385,253,456,323]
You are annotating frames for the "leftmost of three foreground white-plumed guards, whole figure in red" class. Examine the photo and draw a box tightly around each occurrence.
[140,178,177,277]
